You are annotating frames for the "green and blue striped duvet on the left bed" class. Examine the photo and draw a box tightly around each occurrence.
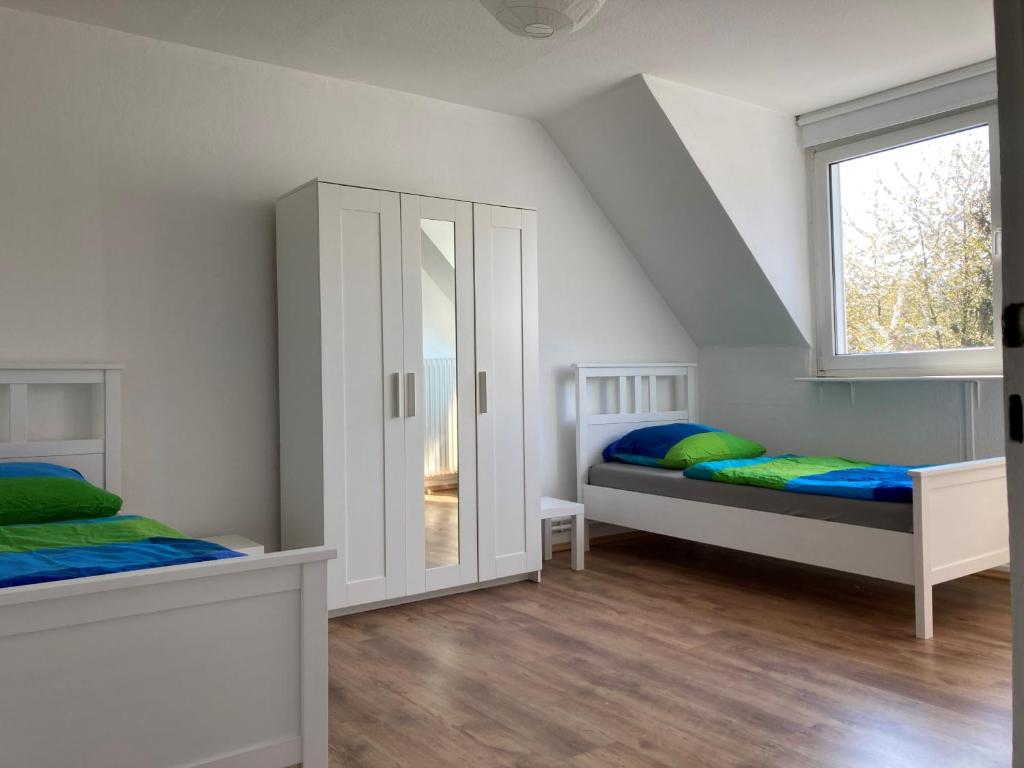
[0,515,244,587]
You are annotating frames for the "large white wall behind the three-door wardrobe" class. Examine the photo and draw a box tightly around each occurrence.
[0,10,695,546]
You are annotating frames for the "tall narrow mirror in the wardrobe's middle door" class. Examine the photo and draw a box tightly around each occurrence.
[420,218,459,569]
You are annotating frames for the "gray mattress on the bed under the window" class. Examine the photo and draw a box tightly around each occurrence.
[590,462,913,534]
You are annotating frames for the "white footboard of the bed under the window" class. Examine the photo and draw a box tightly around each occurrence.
[910,458,1010,639]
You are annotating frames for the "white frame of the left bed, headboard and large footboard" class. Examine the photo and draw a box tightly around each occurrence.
[0,365,334,768]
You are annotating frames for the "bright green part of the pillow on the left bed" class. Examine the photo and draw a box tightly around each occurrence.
[0,477,122,525]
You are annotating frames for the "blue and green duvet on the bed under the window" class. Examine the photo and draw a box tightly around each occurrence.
[683,454,915,503]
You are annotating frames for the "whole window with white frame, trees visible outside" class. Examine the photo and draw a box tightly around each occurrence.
[813,108,1000,375]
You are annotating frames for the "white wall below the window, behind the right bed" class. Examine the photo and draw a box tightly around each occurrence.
[697,347,1004,464]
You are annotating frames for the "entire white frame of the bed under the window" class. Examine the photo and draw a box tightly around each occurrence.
[575,364,1010,639]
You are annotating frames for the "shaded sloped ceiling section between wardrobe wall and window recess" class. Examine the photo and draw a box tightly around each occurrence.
[545,76,810,346]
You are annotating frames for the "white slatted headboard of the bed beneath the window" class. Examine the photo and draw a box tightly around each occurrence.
[574,362,697,501]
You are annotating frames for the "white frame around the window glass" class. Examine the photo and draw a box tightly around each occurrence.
[811,104,1002,376]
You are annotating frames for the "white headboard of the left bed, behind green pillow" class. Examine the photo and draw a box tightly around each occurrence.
[0,364,124,494]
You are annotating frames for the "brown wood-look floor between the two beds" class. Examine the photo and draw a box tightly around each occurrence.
[331,539,1011,768]
